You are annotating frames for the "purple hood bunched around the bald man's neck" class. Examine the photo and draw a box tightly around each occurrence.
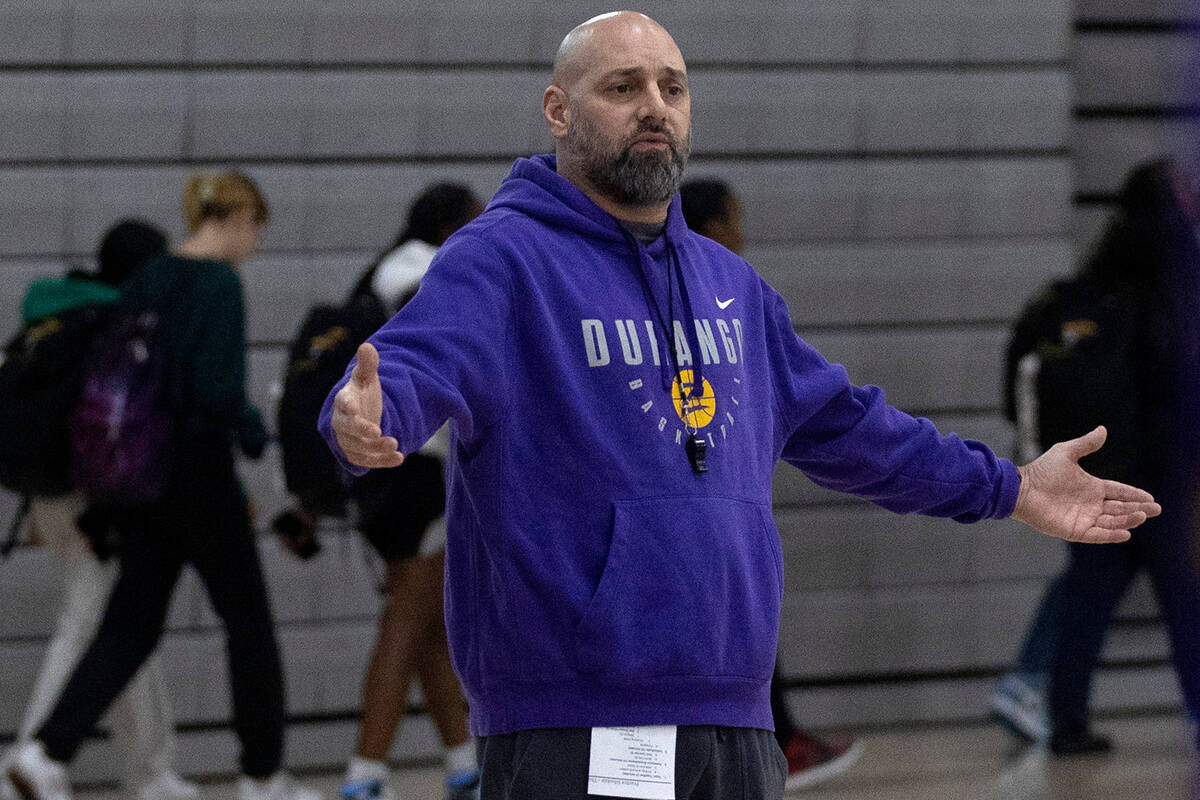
[488,155,688,242]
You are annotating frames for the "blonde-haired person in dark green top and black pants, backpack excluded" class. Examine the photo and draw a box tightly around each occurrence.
[8,174,320,800]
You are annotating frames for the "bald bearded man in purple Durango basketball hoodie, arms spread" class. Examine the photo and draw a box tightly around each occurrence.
[319,12,1158,800]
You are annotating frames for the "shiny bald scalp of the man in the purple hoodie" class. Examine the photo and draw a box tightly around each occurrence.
[553,11,685,90]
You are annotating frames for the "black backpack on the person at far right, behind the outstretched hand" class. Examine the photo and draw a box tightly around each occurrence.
[1007,281,1147,481]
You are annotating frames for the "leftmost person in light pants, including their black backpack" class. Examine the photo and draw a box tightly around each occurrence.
[0,219,199,800]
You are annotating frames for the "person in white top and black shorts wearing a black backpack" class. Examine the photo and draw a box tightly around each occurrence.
[276,184,482,800]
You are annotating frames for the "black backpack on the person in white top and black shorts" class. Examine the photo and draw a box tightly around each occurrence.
[276,261,389,517]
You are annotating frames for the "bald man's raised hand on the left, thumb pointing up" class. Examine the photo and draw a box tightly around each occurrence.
[331,342,404,468]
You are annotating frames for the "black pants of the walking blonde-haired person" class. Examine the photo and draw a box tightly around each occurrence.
[37,444,283,777]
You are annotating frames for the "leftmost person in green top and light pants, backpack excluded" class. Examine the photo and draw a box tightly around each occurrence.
[0,219,199,800]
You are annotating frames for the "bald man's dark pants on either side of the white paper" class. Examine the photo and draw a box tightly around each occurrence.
[480,726,787,800]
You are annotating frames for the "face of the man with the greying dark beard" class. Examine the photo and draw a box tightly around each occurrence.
[562,23,691,206]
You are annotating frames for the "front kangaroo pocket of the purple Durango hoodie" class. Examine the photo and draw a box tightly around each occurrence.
[575,497,782,679]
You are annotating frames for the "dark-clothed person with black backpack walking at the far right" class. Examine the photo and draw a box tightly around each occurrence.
[991,160,1200,756]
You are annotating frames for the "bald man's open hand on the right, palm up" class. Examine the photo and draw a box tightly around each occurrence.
[1013,426,1163,543]
